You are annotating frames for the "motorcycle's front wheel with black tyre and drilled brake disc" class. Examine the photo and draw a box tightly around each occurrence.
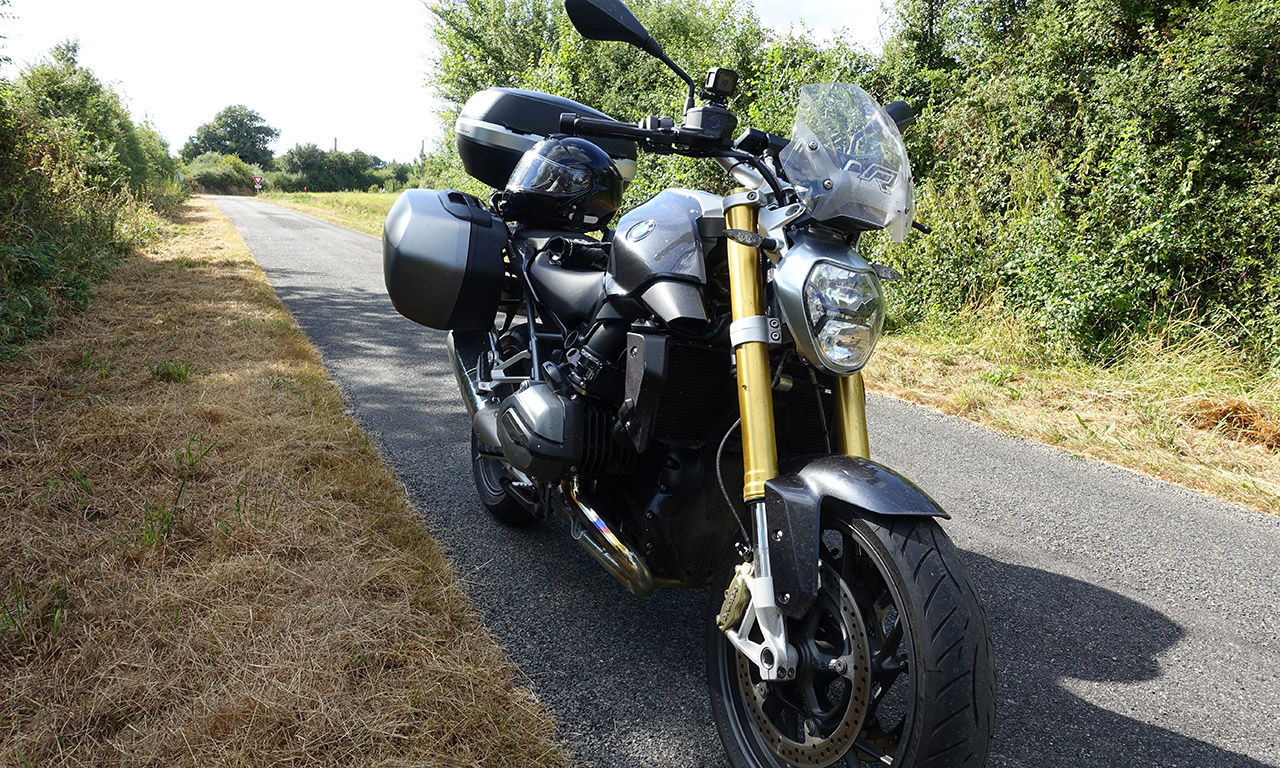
[707,513,995,768]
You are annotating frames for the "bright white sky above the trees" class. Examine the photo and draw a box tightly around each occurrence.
[0,0,887,160]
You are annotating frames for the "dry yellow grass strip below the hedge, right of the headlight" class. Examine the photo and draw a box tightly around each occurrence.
[867,317,1280,515]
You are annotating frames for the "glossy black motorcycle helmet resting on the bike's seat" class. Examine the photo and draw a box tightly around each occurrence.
[498,136,623,232]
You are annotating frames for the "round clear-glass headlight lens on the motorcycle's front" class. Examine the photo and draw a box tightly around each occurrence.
[804,261,884,374]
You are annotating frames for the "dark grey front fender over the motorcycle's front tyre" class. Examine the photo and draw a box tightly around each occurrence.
[764,456,951,618]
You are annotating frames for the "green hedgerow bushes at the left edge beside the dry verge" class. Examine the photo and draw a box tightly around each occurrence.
[0,44,183,357]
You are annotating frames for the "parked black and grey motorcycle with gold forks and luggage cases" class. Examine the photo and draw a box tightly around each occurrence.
[384,0,995,768]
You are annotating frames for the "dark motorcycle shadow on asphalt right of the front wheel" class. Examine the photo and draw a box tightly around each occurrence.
[964,552,1271,768]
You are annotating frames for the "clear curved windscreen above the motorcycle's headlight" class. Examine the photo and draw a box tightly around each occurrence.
[782,83,915,242]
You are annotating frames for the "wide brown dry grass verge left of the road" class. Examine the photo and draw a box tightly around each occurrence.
[0,201,564,767]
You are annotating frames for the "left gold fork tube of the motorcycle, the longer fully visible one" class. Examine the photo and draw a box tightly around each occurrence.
[724,189,778,502]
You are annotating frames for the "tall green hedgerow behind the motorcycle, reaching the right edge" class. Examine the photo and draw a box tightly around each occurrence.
[419,0,1280,362]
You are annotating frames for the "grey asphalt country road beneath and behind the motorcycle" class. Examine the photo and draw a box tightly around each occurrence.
[215,197,1280,768]
